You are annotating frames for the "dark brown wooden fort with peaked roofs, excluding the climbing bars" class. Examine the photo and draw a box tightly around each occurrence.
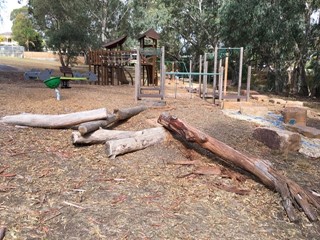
[88,28,159,89]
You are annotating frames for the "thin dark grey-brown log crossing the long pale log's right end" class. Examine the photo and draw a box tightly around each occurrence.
[78,106,147,135]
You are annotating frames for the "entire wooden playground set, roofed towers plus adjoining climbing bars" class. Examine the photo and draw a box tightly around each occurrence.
[88,28,251,103]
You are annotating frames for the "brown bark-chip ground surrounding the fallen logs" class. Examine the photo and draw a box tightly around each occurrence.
[0,58,320,239]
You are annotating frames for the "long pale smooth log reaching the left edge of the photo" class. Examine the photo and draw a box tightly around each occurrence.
[0,108,107,128]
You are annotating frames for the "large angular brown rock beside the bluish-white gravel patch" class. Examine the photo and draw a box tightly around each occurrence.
[253,127,301,152]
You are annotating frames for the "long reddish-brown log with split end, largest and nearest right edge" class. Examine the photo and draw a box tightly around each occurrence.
[158,113,320,222]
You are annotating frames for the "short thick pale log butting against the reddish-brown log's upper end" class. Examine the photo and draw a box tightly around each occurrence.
[106,127,166,158]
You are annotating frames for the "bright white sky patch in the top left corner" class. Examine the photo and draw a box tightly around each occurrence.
[0,0,28,33]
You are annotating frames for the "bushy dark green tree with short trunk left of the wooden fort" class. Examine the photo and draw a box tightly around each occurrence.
[29,0,96,66]
